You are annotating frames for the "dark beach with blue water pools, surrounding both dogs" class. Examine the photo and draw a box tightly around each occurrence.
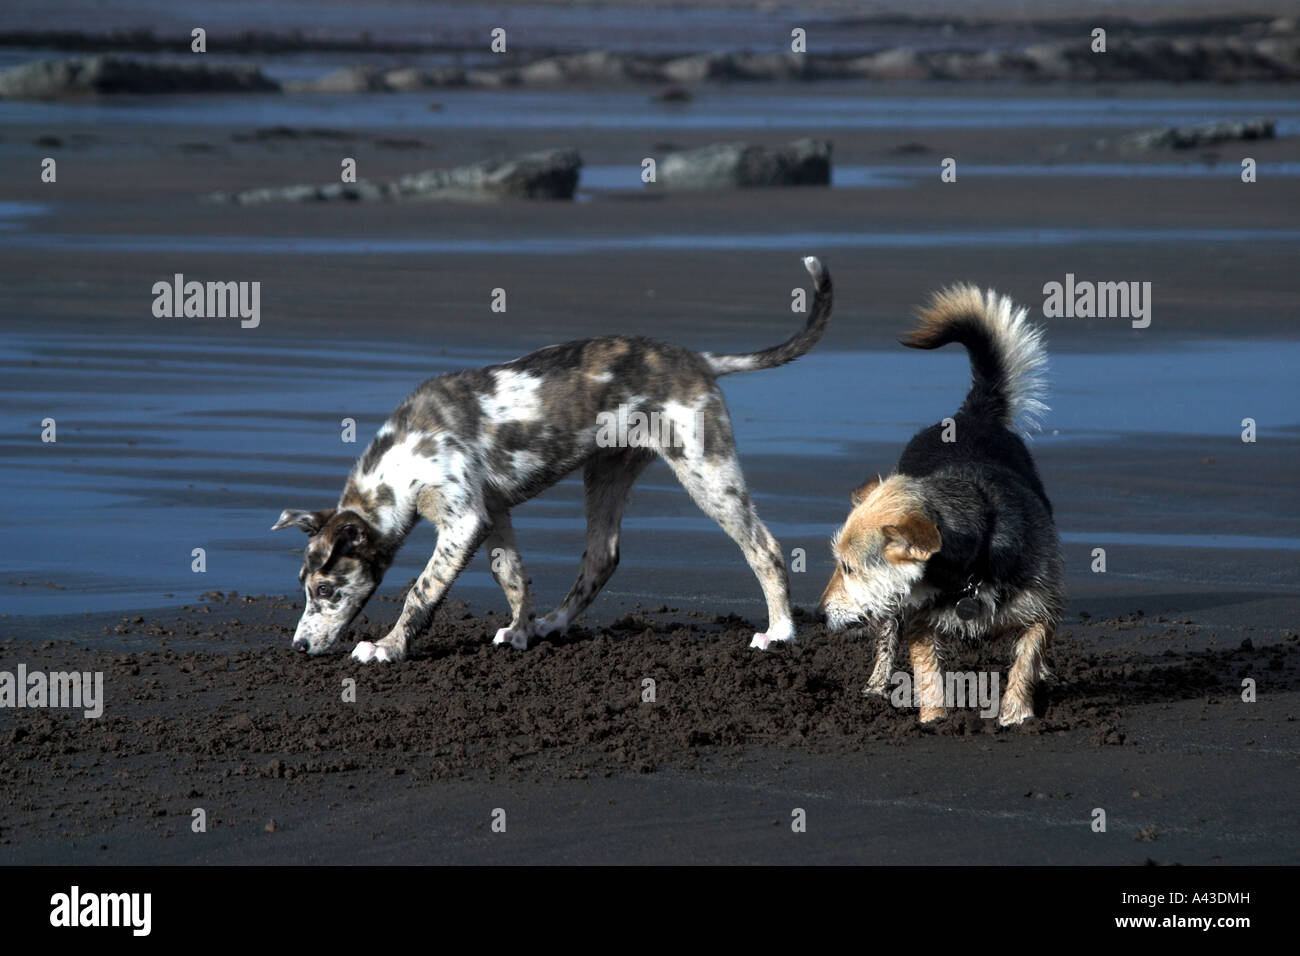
[0,5,1300,865]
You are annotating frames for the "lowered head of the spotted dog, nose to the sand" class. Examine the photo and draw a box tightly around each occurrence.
[272,509,390,654]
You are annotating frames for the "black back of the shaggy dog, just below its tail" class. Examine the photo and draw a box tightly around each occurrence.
[898,412,1052,515]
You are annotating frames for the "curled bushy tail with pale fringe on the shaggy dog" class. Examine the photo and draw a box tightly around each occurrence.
[900,285,1048,432]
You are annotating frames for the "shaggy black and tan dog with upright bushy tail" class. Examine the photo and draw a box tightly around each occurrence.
[820,286,1065,726]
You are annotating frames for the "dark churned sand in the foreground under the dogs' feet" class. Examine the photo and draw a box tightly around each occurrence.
[0,594,1300,864]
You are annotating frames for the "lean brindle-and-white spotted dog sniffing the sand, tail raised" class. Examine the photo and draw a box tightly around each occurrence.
[273,256,832,661]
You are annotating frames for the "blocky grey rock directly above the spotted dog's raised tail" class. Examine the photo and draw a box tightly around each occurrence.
[655,139,831,189]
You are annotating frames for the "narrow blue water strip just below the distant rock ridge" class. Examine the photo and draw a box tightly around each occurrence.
[0,83,1300,137]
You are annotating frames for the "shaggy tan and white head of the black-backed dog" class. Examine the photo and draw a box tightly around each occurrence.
[820,475,943,631]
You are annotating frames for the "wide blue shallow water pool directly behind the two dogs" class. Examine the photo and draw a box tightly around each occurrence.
[0,333,1300,614]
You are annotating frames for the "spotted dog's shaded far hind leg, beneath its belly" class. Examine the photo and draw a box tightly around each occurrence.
[537,449,654,637]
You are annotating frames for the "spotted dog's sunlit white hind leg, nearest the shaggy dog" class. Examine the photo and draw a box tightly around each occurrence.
[662,426,794,650]
